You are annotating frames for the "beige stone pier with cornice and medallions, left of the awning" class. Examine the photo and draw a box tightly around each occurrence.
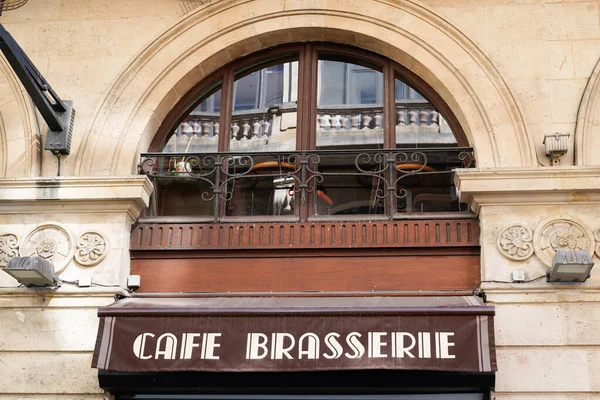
[0,176,152,399]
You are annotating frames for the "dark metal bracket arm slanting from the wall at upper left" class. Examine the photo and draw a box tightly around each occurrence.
[0,24,75,156]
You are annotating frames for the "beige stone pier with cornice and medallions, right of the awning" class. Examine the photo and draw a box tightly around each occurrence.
[457,167,600,399]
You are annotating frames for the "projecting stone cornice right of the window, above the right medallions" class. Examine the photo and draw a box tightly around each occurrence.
[455,167,600,213]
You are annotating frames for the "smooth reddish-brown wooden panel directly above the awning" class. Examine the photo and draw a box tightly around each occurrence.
[131,254,480,292]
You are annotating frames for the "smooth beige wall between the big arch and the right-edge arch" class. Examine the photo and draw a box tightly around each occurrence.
[424,0,600,165]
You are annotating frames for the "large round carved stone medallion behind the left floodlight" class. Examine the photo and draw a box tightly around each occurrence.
[21,224,74,274]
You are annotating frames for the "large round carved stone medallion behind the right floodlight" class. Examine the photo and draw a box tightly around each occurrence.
[534,218,594,267]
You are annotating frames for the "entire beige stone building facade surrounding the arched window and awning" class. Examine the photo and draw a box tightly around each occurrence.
[0,0,600,400]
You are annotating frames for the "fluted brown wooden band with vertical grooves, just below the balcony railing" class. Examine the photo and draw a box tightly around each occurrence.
[131,219,479,251]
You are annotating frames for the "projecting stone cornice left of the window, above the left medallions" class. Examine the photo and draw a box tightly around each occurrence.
[0,176,152,220]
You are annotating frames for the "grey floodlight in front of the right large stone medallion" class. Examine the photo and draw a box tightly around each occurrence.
[546,250,594,282]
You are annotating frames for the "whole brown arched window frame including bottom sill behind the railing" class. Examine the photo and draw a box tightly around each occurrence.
[148,42,471,223]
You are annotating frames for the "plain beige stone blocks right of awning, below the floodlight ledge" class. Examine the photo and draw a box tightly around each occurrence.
[487,288,600,399]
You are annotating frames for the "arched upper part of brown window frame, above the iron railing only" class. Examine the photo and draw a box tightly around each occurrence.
[148,43,469,153]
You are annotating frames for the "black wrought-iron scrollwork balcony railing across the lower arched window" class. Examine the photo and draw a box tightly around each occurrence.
[139,147,473,222]
